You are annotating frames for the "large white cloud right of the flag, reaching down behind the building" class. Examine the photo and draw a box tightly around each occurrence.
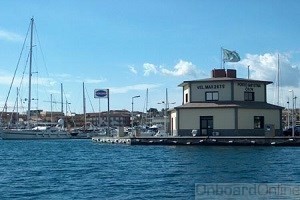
[231,53,300,107]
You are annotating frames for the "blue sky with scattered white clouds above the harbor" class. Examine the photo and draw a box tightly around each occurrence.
[0,0,300,113]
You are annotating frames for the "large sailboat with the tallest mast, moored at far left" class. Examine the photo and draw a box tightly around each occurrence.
[0,18,71,140]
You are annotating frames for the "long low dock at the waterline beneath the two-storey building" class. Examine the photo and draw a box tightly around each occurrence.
[92,136,300,146]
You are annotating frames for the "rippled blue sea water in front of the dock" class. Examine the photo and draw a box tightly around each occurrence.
[0,140,300,200]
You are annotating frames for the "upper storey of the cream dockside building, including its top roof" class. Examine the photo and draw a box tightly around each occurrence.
[179,69,272,104]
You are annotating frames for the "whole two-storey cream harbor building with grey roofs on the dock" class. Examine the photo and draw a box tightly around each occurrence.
[168,69,283,137]
